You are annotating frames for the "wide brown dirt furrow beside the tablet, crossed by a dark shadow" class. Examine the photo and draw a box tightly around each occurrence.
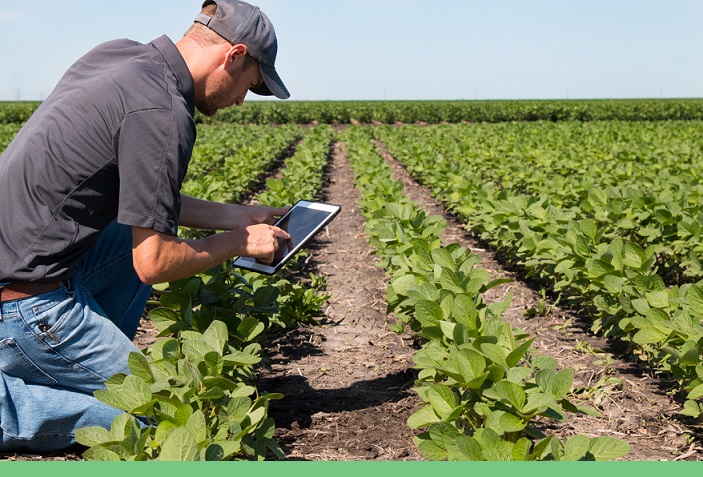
[260,144,421,460]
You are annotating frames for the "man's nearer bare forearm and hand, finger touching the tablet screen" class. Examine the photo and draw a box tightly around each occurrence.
[132,224,290,285]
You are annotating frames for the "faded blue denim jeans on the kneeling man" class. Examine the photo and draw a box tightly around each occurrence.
[0,222,151,452]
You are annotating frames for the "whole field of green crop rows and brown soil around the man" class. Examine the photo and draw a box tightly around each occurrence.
[0,100,703,460]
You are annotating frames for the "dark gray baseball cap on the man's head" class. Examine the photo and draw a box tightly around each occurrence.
[195,0,290,99]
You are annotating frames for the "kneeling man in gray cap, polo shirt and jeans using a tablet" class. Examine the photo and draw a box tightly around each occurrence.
[0,0,289,452]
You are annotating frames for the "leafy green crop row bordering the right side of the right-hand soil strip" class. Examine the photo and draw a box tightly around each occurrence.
[380,123,703,417]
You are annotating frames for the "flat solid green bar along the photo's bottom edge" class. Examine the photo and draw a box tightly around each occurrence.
[0,461,703,477]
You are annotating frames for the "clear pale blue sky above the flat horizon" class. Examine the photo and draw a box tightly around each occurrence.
[0,0,703,100]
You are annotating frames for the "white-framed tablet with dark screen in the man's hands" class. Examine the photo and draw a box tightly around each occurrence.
[233,200,342,275]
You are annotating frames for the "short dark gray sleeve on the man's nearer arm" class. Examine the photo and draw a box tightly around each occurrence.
[116,109,194,235]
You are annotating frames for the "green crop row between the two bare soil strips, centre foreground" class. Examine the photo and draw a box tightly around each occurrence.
[343,124,629,461]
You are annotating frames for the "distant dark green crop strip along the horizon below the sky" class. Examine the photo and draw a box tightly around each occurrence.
[0,99,703,124]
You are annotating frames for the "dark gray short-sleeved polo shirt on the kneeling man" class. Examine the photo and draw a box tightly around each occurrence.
[0,36,195,283]
